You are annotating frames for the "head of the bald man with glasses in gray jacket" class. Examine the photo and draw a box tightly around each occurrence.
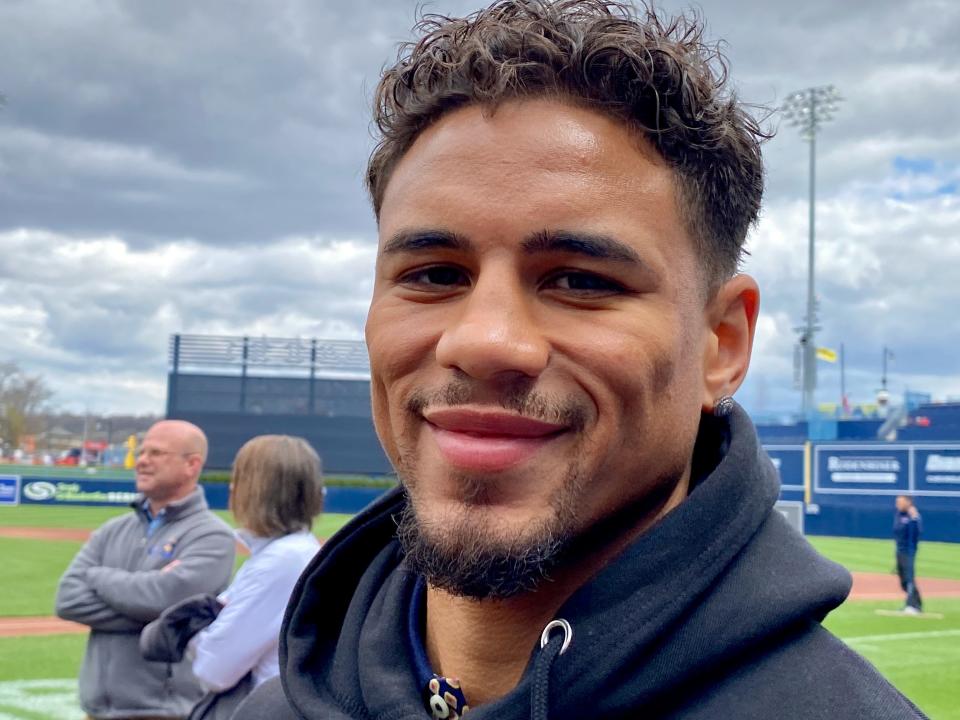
[135,423,199,502]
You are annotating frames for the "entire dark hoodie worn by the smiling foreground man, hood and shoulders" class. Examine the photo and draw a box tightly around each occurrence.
[235,408,924,720]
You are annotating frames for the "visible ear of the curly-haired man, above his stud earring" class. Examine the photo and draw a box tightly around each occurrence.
[702,275,760,413]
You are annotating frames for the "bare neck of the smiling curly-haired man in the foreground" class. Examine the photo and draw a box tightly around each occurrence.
[426,478,689,707]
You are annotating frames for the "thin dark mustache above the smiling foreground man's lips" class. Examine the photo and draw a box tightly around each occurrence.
[404,379,588,430]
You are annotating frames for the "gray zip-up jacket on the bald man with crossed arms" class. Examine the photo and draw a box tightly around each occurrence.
[56,487,236,718]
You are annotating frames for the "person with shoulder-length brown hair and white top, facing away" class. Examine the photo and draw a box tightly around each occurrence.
[140,435,323,720]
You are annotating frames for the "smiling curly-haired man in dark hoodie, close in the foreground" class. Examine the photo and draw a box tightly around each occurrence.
[237,0,922,720]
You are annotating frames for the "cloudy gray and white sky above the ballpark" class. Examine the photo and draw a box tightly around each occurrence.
[0,0,960,413]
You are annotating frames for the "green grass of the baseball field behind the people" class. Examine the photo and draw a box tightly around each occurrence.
[0,506,960,720]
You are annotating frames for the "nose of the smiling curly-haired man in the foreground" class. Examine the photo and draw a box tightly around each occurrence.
[437,273,550,380]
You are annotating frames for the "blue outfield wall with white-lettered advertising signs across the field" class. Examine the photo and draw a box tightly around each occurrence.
[0,442,960,542]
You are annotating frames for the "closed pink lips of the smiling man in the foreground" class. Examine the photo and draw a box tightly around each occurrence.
[423,408,567,472]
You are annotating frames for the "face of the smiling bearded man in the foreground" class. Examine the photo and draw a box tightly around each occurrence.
[366,100,709,596]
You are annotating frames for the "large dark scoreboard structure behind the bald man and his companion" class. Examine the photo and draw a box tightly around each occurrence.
[167,335,392,475]
